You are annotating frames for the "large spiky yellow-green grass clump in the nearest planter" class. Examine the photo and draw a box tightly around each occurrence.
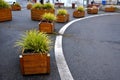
[15,30,51,54]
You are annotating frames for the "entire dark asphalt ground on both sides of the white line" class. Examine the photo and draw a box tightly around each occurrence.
[0,5,120,80]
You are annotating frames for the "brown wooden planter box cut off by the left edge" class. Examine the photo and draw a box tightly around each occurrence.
[0,8,12,22]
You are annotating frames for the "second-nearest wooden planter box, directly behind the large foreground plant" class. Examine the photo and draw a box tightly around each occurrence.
[39,21,54,33]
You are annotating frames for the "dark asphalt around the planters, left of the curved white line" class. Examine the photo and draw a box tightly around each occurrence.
[0,8,60,80]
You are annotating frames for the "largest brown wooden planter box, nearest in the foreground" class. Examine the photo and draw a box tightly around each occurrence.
[20,53,50,75]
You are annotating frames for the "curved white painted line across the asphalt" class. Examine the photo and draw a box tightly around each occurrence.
[54,13,119,80]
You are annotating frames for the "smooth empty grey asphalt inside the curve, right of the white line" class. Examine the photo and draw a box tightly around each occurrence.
[63,14,120,80]
